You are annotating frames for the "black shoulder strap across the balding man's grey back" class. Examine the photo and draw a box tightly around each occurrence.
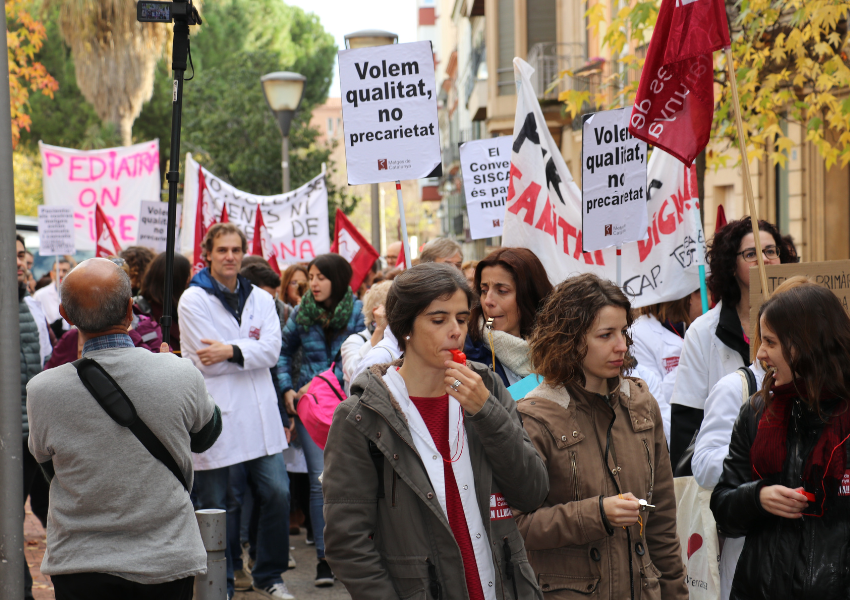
[71,358,189,492]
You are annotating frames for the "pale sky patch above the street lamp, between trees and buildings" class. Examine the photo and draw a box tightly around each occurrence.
[284,0,417,98]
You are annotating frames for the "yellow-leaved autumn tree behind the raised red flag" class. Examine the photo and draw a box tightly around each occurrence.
[560,0,850,168]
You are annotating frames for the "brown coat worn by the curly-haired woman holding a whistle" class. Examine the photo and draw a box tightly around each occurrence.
[514,378,688,600]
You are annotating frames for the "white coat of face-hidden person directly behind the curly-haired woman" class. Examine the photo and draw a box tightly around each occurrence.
[631,315,684,446]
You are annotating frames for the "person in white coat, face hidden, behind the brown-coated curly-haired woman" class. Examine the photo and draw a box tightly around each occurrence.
[631,290,702,448]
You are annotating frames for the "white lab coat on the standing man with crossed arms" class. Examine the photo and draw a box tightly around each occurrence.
[177,286,287,471]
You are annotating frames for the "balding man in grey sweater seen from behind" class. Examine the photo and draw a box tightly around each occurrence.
[27,258,221,600]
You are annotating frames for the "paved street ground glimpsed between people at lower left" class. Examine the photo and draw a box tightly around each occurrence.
[24,503,350,600]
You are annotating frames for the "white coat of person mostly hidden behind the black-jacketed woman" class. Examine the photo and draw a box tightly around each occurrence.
[691,361,765,600]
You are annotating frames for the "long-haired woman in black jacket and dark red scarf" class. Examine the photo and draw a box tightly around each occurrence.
[711,285,850,600]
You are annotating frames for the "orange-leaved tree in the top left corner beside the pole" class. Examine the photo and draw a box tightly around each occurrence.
[5,0,59,147]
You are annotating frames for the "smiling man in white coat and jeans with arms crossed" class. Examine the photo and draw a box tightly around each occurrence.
[177,223,293,600]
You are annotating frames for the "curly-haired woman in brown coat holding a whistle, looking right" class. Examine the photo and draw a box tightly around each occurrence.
[515,274,688,600]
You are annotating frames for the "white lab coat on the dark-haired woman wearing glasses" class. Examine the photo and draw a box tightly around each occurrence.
[670,302,744,410]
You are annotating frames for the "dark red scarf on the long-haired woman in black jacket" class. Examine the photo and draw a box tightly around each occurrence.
[750,380,850,504]
